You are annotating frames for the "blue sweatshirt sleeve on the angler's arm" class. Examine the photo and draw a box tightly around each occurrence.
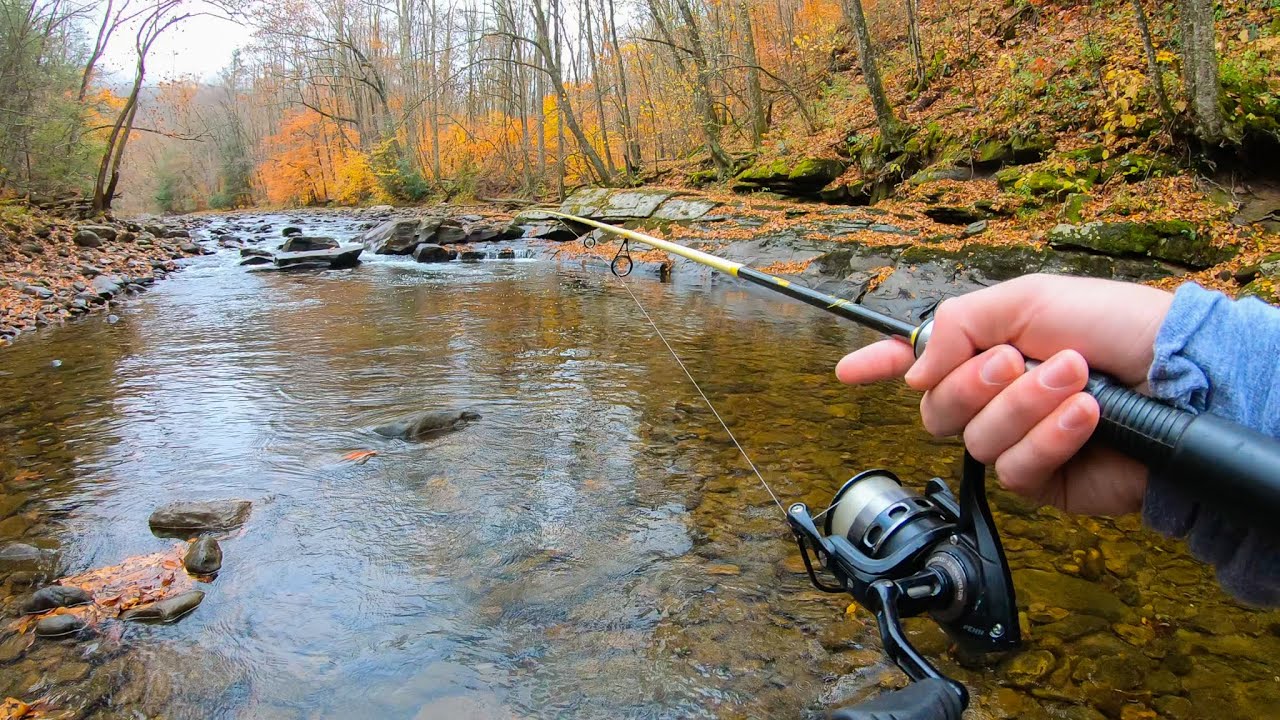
[1142,283,1280,606]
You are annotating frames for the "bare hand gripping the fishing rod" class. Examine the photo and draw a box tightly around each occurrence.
[836,274,1174,515]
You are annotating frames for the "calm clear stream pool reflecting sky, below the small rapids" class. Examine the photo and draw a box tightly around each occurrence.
[0,212,1280,720]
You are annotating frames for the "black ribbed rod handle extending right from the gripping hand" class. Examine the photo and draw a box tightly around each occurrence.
[911,320,1280,527]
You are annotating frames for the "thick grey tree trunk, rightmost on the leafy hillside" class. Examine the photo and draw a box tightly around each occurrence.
[1179,0,1226,145]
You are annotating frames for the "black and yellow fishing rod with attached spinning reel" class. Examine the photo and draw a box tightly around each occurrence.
[544,210,1280,720]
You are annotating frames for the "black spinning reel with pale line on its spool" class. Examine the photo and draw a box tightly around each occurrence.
[787,452,1020,720]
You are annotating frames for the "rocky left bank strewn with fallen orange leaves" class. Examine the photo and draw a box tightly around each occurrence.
[0,206,211,346]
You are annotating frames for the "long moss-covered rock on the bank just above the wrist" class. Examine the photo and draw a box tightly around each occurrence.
[1046,220,1236,270]
